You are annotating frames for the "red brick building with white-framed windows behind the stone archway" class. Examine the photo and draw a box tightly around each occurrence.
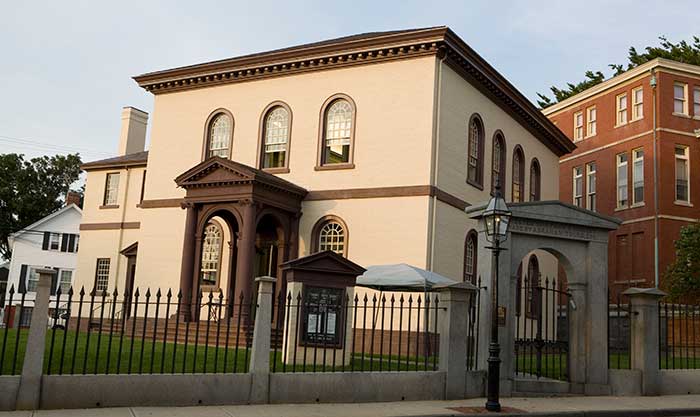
[543,59,700,293]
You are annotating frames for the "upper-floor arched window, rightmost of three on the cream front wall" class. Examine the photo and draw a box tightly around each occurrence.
[319,95,355,168]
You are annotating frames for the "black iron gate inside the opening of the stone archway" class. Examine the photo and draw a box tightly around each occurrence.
[515,276,571,380]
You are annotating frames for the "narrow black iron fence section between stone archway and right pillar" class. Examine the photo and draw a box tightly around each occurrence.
[608,291,631,369]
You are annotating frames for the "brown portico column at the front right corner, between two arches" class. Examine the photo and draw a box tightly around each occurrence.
[236,200,256,310]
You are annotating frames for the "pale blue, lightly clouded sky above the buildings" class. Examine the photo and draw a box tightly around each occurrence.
[0,0,700,161]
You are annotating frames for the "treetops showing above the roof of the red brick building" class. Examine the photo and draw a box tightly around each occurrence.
[537,36,700,109]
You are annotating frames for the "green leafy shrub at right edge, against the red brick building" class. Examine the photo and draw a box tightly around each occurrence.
[664,224,700,299]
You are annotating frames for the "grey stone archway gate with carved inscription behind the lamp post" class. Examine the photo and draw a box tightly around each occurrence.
[466,201,620,396]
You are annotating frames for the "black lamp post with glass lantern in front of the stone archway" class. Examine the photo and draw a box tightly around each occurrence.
[483,180,511,411]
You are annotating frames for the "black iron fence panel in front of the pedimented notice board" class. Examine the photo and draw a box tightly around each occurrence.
[271,287,445,372]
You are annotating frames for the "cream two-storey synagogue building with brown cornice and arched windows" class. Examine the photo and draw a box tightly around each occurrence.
[77,27,574,306]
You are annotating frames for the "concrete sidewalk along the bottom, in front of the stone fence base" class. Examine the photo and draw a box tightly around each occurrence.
[0,395,700,417]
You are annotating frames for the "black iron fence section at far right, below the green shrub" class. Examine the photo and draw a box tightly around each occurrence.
[659,302,700,369]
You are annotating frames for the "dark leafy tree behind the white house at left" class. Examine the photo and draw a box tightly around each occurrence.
[0,154,82,259]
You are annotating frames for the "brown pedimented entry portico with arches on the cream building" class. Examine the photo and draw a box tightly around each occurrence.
[175,157,307,317]
